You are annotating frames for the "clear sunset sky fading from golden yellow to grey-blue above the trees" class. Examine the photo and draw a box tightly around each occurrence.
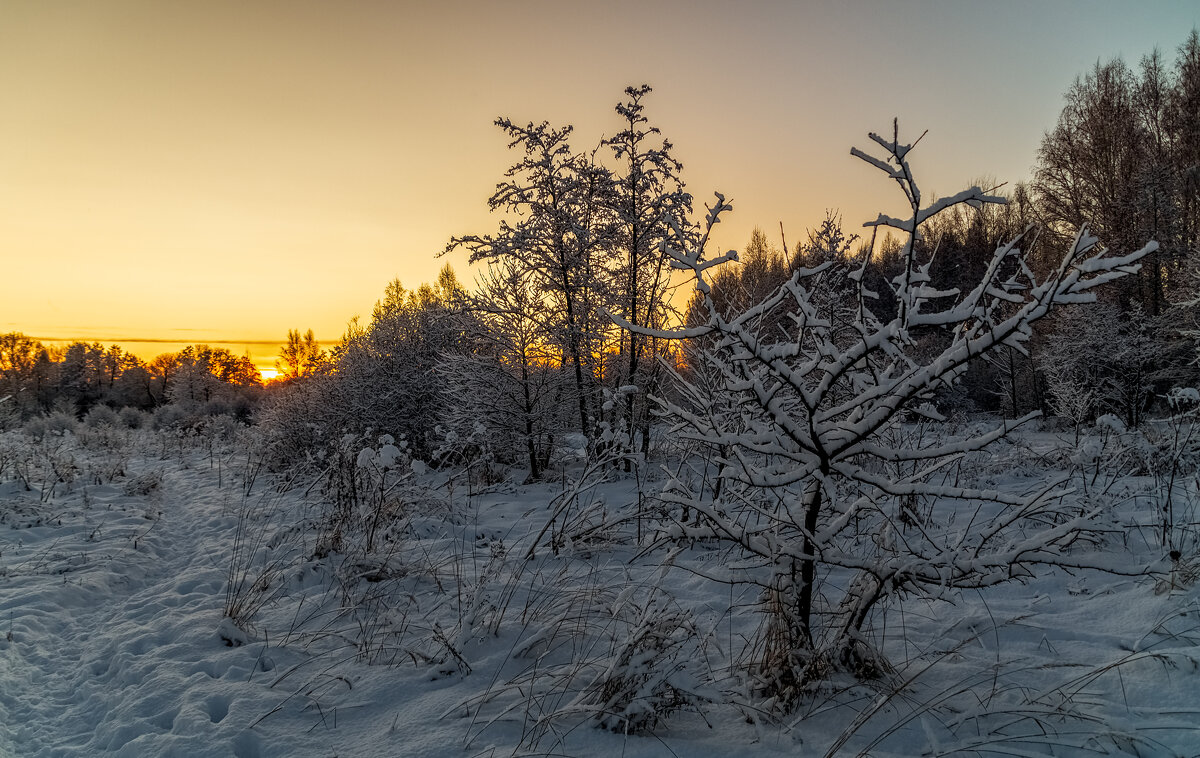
[0,0,1200,365]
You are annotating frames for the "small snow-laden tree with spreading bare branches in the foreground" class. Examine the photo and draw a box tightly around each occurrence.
[625,121,1153,706]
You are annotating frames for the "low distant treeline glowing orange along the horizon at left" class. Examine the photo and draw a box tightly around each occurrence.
[0,332,263,422]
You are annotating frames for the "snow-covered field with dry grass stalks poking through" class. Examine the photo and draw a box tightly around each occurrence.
[0,428,1200,758]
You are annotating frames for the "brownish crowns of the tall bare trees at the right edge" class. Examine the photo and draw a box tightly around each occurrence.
[1033,30,1200,317]
